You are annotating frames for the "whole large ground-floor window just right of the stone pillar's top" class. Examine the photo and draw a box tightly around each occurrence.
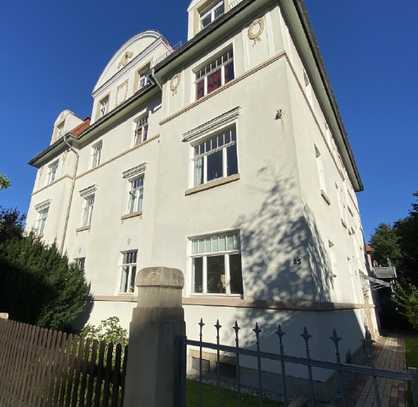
[192,232,243,294]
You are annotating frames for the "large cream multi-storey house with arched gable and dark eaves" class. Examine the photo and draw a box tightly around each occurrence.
[27,0,376,386]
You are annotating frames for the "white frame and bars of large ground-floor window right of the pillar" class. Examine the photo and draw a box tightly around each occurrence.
[189,230,244,297]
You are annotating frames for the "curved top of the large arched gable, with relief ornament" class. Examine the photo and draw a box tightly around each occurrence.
[93,31,171,93]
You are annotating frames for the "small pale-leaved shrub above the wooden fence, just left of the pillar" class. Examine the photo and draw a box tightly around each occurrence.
[81,317,128,346]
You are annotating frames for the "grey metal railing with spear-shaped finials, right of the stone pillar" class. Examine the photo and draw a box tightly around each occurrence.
[182,319,418,407]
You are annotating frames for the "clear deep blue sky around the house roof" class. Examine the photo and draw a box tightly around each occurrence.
[0,0,418,241]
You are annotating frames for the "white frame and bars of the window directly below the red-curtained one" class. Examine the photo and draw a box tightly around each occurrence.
[191,123,239,187]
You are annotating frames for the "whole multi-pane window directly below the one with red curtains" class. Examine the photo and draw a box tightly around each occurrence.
[194,126,238,186]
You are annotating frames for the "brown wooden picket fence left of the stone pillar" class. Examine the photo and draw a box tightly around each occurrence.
[0,320,127,407]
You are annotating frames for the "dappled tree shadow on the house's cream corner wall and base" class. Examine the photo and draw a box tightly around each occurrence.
[211,166,363,402]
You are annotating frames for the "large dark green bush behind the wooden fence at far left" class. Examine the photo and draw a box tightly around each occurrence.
[0,222,91,331]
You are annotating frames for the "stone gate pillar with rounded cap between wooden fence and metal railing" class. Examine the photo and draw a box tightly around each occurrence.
[124,267,186,407]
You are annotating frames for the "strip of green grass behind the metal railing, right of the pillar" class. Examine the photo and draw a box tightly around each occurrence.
[187,381,282,407]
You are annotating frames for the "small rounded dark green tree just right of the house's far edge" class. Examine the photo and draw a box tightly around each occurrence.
[370,223,401,266]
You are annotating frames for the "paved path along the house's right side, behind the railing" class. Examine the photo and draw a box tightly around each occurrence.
[351,336,406,407]
